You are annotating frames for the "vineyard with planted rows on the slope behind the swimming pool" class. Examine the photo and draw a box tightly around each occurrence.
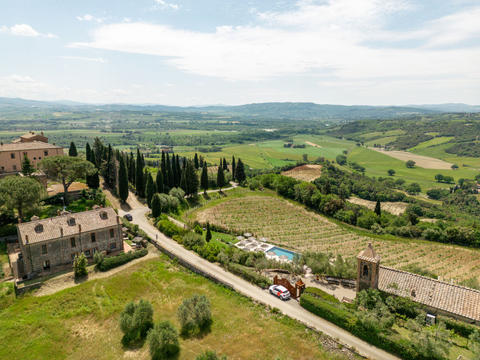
[196,195,480,281]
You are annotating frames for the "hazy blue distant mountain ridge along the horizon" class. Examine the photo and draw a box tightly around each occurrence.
[0,97,480,122]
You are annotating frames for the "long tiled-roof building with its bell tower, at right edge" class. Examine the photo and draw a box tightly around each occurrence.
[357,244,480,325]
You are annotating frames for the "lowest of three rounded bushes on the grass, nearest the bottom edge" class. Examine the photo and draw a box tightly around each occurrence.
[147,321,180,360]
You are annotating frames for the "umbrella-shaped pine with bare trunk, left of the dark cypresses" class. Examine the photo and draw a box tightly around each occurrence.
[40,156,95,204]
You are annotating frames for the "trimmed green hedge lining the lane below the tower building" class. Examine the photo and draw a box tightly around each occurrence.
[300,293,437,360]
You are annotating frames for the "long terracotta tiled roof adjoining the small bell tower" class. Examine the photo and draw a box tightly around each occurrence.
[378,266,480,321]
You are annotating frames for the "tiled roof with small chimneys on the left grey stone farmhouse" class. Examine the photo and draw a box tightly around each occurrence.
[17,207,117,244]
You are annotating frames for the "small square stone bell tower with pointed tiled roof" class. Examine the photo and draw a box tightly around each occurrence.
[357,243,380,292]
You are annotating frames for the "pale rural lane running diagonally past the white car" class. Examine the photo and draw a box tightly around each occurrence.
[119,205,399,360]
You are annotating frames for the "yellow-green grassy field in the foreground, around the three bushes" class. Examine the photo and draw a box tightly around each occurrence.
[0,257,352,360]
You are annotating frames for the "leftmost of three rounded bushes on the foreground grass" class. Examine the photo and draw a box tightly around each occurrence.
[120,299,153,345]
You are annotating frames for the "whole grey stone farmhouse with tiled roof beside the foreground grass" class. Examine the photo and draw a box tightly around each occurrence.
[11,207,123,279]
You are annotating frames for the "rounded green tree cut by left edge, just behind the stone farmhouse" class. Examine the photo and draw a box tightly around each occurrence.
[0,176,46,219]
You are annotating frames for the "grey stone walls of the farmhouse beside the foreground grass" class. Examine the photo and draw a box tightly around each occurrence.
[20,224,123,274]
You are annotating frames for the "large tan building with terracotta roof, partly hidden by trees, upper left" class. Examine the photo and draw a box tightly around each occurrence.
[0,132,63,176]
